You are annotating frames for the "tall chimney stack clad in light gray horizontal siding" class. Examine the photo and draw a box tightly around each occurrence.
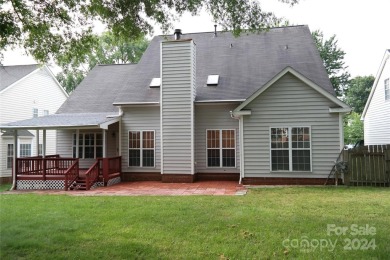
[161,41,195,174]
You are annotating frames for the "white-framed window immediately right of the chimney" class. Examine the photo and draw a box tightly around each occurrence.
[207,129,236,167]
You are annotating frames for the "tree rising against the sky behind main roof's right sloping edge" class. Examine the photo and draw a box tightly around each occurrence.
[312,30,350,97]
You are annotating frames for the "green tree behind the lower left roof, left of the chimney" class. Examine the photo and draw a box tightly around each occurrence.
[57,32,149,93]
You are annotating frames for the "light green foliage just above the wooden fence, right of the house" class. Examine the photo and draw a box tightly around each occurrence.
[344,112,364,144]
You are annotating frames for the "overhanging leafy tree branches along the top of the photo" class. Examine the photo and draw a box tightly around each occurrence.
[0,0,299,62]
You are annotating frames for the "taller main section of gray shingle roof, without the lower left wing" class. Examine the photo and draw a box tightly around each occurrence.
[115,26,334,103]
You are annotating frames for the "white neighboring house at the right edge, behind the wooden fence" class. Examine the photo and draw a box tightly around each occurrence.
[362,49,390,145]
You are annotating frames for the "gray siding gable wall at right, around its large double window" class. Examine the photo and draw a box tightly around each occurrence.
[244,73,340,177]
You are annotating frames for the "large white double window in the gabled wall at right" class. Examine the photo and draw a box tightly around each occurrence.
[270,127,311,171]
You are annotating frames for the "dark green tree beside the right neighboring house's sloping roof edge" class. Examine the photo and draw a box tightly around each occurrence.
[345,76,375,114]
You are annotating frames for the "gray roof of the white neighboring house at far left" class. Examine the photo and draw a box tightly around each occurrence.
[0,64,39,91]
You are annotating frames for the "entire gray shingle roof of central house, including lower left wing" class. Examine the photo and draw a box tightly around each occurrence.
[58,26,334,113]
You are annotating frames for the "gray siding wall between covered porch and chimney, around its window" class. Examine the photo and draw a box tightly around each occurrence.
[121,106,161,172]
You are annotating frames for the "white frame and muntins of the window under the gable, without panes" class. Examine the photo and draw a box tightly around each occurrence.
[268,125,313,173]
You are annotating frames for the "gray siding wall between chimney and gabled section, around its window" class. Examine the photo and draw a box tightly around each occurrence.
[195,104,240,173]
